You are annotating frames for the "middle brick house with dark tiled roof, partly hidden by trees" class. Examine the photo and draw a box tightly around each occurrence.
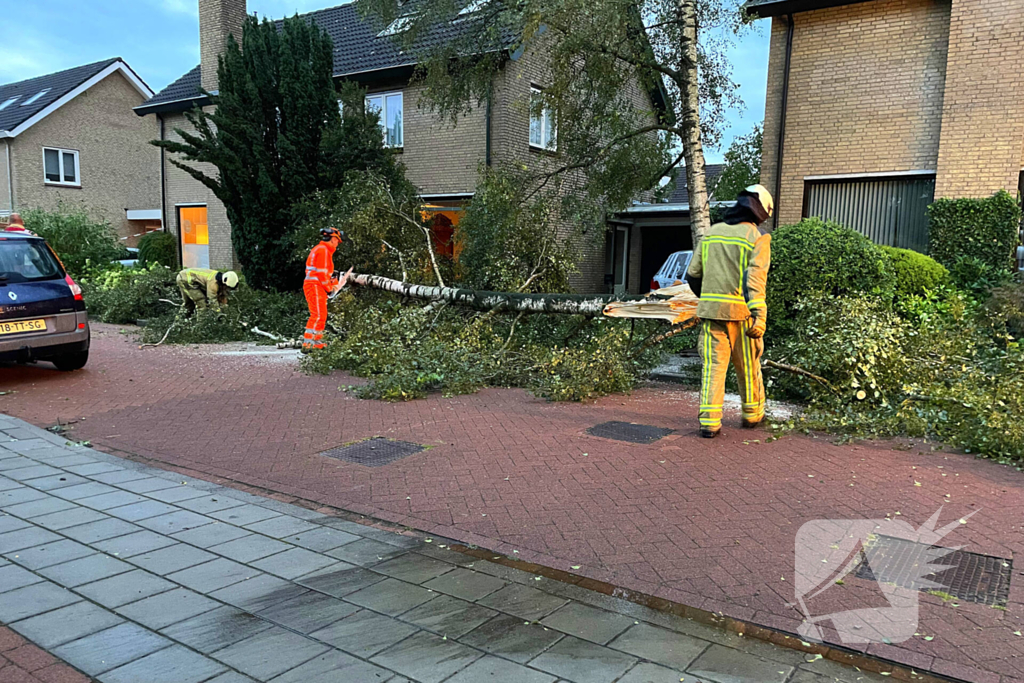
[135,0,667,292]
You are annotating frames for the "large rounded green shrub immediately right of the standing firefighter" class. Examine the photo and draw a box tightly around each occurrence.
[767,218,895,331]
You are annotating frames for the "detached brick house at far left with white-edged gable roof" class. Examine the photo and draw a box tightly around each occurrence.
[0,57,161,244]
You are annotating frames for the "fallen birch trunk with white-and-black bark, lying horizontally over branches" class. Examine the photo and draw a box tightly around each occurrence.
[348,273,644,315]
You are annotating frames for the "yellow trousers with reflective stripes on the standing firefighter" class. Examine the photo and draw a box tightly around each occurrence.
[698,318,765,431]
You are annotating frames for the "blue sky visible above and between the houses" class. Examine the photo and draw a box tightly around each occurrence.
[0,0,768,162]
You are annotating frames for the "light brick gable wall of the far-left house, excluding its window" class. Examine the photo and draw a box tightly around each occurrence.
[9,73,160,237]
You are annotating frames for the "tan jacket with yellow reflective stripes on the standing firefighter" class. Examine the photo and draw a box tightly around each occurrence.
[687,223,771,321]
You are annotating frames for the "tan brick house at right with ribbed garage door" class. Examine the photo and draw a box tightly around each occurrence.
[746,0,1024,251]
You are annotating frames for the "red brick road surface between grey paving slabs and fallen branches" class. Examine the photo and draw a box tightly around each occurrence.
[0,326,1024,683]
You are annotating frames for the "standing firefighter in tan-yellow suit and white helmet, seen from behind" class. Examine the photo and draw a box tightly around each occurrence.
[686,185,774,438]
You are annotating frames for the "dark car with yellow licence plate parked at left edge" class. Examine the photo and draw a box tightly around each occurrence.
[0,230,89,370]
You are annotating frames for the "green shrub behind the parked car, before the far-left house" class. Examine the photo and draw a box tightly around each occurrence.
[22,204,125,280]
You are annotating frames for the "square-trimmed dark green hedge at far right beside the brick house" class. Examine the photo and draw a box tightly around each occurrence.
[928,190,1021,270]
